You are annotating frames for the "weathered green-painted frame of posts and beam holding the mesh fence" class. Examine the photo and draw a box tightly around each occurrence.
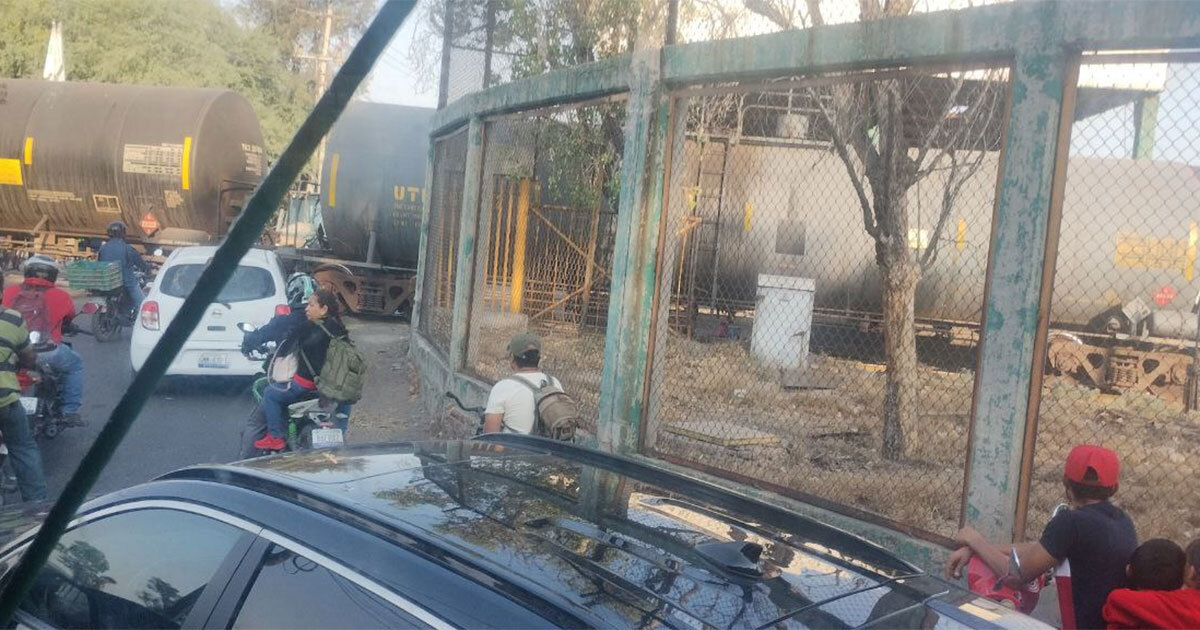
[412,0,1200,565]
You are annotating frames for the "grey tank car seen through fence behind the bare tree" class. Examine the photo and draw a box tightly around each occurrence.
[672,140,1200,397]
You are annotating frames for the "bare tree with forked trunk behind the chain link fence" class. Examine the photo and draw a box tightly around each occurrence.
[745,0,1004,460]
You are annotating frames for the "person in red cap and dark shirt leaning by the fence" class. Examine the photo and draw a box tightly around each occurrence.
[946,444,1138,630]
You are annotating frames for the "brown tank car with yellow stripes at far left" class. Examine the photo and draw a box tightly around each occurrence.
[0,79,265,247]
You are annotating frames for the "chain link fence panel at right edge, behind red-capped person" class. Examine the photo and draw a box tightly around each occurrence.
[1026,57,1200,544]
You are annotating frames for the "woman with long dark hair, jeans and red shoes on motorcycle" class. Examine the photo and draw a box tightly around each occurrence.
[254,289,346,451]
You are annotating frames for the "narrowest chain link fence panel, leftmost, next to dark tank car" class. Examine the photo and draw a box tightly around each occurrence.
[420,128,467,353]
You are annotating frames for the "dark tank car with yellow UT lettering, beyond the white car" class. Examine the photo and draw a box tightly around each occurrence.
[283,102,434,314]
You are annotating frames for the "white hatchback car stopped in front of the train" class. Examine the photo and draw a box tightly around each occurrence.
[130,246,288,376]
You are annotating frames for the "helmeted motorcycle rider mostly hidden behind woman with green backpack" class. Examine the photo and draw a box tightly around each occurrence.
[241,277,350,458]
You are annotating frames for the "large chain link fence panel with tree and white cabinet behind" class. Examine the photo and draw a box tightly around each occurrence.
[644,66,1007,535]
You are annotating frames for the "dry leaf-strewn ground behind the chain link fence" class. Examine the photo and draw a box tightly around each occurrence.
[463,326,1200,542]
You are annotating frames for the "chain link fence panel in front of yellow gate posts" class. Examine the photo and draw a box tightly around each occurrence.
[467,101,625,432]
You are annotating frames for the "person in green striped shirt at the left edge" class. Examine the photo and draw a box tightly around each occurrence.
[0,275,47,500]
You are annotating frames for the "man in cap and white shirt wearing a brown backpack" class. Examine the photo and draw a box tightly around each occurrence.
[484,332,580,440]
